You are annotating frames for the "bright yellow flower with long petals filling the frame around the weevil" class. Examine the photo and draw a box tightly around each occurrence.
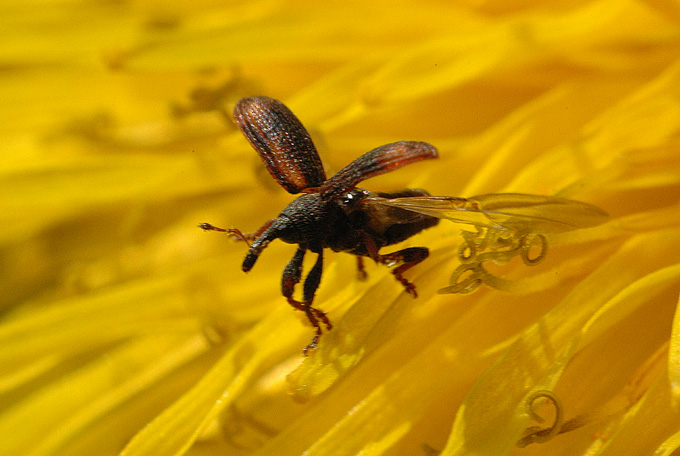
[0,0,680,456]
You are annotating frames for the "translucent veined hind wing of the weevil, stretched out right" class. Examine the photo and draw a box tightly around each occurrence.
[377,193,609,233]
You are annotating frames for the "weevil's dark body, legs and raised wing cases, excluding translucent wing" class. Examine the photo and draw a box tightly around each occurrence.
[199,96,439,354]
